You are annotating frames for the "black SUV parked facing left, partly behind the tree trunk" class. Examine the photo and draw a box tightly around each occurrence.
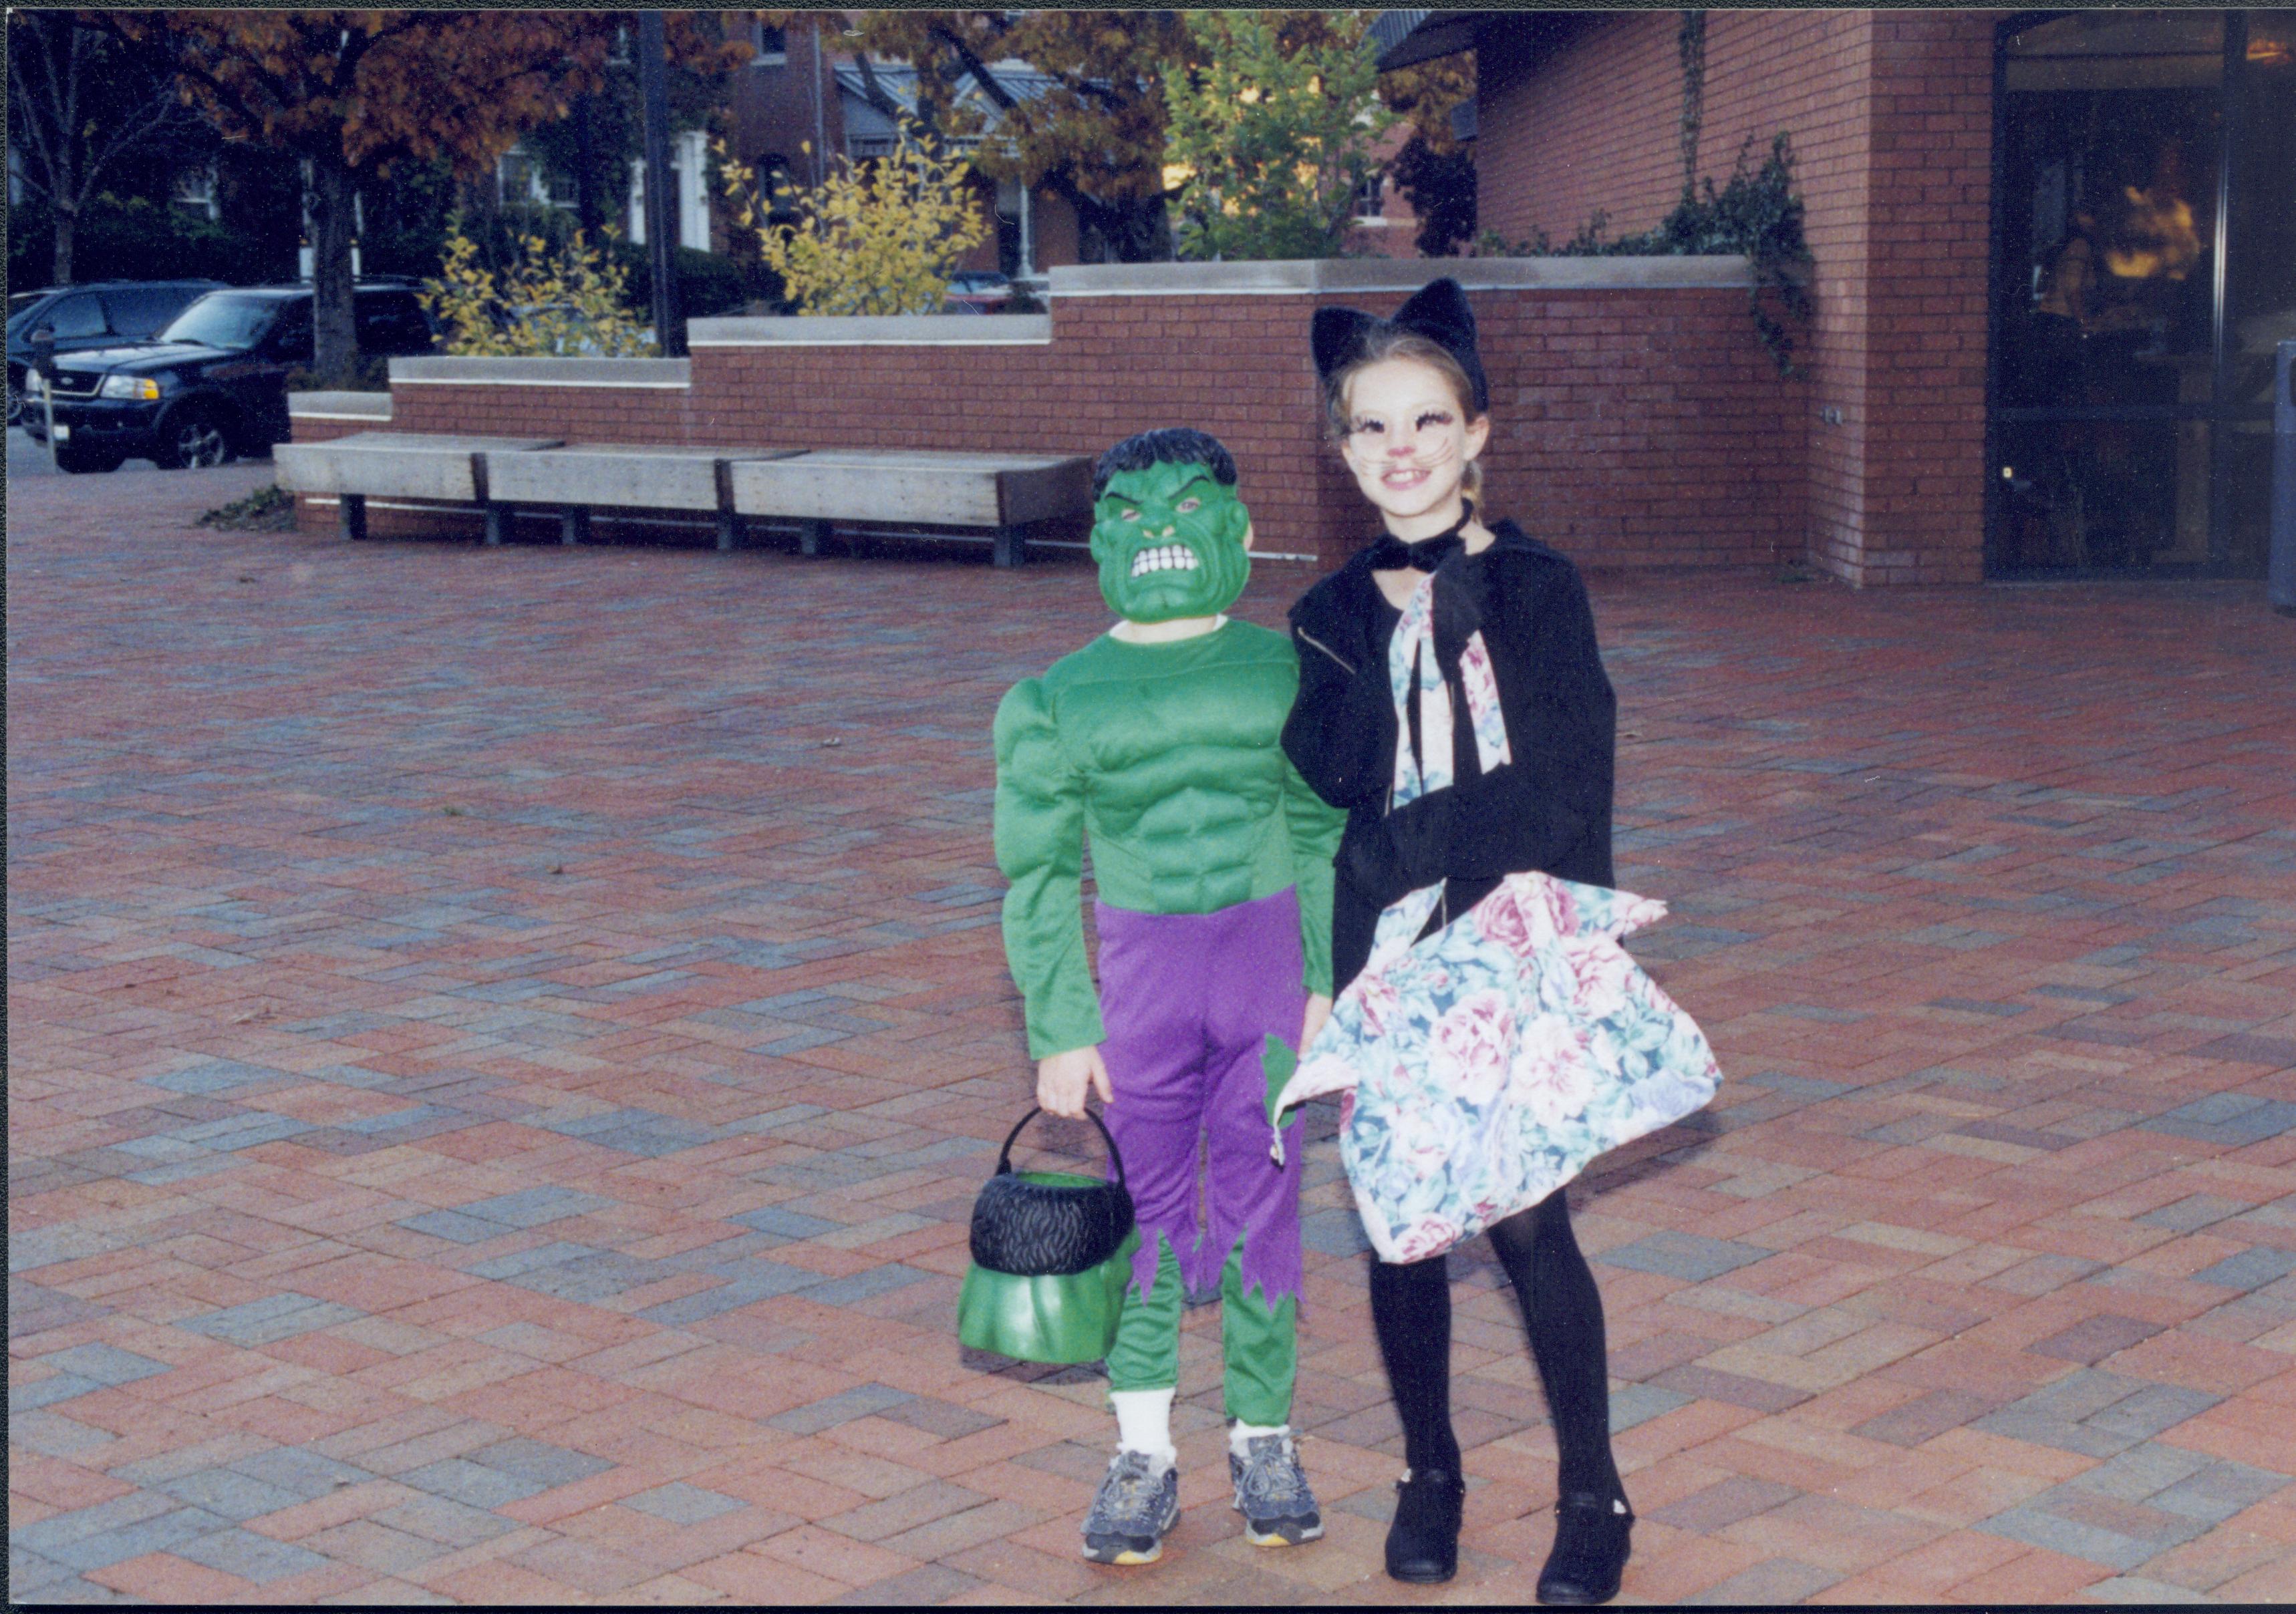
[23,285,438,471]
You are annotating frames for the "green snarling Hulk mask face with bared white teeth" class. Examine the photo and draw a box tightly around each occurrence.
[1093,462,1252,622]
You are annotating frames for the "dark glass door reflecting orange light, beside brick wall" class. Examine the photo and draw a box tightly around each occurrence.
[1986,11,2296,577]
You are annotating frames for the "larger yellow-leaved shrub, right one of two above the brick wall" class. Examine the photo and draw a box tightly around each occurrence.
[716,122,987,315]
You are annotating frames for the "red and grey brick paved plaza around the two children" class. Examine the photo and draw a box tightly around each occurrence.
[7,466,2296,1605]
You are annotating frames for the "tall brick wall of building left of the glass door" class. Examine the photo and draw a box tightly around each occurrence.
[1476,11,2005,583]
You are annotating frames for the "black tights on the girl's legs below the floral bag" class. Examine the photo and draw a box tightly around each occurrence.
[1371,1189,1623,1497]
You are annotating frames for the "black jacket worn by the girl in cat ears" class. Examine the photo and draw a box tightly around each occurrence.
[1284,521,1616,985]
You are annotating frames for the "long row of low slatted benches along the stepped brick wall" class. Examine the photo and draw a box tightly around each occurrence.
[275,432,1093,567]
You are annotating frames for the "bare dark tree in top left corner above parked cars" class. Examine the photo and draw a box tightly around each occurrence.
[7,9,197,285]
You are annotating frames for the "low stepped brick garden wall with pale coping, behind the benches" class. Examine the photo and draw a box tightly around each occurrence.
[296,259,1805,581]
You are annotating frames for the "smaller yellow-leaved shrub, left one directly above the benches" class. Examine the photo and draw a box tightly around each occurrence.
[420,216,662,358]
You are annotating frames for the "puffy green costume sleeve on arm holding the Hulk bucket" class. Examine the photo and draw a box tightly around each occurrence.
[994,677,1102,1058]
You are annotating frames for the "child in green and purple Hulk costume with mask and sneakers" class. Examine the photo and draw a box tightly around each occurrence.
[996,427,1343,1563]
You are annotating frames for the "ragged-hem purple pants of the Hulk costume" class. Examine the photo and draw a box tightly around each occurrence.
[1093,889,1306,1304]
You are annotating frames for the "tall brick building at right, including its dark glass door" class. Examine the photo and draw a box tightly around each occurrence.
[1380,9,2296,583]
